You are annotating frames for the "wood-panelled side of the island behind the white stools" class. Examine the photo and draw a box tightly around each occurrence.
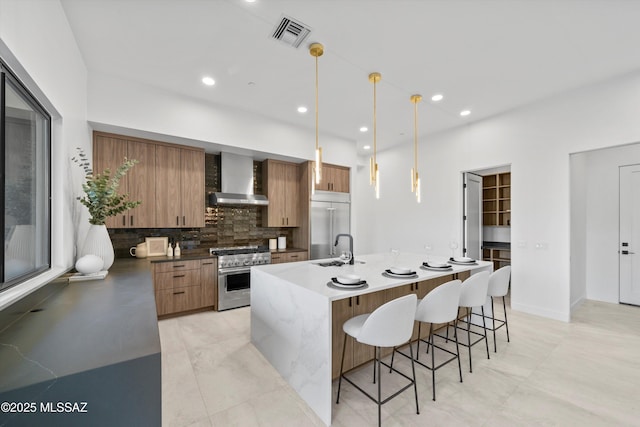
[331,271,470,379]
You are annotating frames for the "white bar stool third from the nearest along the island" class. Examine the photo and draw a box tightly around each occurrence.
[458,271,490,372]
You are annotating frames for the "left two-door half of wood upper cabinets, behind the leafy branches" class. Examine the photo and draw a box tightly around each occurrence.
[93,133,156,228]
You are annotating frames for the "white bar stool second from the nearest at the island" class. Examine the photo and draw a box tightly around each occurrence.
[391,280,462,401]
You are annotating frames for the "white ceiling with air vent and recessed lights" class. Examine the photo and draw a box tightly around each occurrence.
[62,0,640,154]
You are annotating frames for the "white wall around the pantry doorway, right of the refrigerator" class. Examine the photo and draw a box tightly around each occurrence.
[357,73,640,320]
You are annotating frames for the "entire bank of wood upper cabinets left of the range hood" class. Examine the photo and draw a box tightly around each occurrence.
[93,132,205,228]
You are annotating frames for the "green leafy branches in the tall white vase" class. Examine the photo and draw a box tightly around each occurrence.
[71,148,142,225]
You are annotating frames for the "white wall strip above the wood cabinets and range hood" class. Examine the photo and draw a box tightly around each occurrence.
[88,72,356,166]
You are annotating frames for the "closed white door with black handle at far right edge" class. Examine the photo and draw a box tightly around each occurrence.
[618,165,640,305]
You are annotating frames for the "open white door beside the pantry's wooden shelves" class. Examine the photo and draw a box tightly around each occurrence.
[463,172,482,259]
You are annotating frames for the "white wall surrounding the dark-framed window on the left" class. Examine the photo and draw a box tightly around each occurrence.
[0,0,90,307]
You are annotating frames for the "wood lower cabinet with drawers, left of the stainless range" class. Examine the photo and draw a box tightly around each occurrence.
[153,260,218,317]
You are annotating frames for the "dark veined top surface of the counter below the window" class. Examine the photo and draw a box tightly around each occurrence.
[0,259,160,392]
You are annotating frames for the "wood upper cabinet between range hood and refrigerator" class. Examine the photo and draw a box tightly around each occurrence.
[262,159,300,227]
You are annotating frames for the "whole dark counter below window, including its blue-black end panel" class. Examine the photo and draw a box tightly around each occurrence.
[0,258,162,427]
